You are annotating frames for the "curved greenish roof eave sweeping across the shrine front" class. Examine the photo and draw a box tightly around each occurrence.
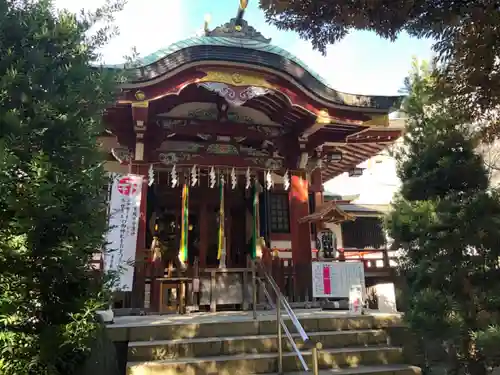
[104,36,402,110]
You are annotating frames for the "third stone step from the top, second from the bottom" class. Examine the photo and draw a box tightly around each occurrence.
[127,346,406,375]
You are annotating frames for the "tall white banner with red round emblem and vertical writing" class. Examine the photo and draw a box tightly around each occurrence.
[104,174,143,292]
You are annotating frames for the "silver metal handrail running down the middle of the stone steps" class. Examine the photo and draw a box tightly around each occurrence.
[252,260,309,374]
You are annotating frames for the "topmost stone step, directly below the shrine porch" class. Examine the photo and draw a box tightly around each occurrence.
[114,313,401,341]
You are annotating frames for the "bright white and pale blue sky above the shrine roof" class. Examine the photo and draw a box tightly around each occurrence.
[55,0,432,95]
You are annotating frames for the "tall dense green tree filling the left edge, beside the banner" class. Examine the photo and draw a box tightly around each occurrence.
[0,0,122,375]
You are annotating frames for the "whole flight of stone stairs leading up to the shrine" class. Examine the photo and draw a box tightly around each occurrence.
[112,312,420,375]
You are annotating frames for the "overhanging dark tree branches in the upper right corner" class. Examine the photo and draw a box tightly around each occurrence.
[260,0,500,139]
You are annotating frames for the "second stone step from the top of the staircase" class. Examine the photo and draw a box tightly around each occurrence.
[128,329,387,361]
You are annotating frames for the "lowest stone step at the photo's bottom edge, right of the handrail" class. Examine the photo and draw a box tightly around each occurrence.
[262,365,422,375]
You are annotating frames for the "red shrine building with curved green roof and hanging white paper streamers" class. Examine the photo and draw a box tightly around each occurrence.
[100,12,402,312]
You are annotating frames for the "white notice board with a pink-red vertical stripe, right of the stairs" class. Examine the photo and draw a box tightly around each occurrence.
[312,262,365,298]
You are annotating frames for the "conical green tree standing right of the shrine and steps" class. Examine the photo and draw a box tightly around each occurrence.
[386,60,500,375]
